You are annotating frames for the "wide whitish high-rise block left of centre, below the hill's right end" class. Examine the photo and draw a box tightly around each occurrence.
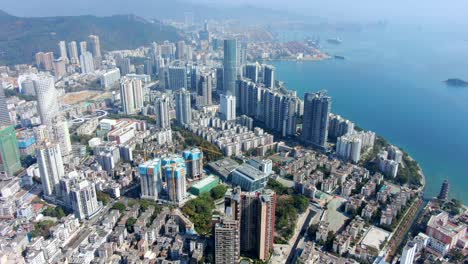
[120,77,144,115]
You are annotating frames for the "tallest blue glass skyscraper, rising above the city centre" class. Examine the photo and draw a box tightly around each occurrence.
[223,39,238,96]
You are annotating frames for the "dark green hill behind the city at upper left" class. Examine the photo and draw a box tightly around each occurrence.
[0,10,183,65]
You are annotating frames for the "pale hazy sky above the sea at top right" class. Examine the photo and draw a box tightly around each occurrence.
[189,0,468,23]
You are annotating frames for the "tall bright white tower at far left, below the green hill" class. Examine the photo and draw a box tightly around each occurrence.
[33,74,59,125]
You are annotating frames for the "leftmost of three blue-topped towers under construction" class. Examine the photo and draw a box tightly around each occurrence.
[138,158,162,200]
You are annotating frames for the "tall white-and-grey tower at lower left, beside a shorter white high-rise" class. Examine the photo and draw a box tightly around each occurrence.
[36,142,65,196]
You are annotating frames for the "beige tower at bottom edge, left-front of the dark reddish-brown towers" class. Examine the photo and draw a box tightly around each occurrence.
[215,218,240,264]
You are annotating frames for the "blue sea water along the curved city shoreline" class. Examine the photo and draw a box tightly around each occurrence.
[273,26,468,203]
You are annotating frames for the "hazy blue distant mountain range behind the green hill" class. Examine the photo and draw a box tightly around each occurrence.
[2,0,311,25]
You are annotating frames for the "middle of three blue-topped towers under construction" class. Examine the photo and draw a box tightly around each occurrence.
[162,154,187,204]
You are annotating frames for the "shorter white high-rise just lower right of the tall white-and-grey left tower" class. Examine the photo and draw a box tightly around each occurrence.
[70,180,101,219]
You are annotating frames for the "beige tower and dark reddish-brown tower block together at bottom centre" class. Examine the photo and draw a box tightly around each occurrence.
[214,188,276,263]
